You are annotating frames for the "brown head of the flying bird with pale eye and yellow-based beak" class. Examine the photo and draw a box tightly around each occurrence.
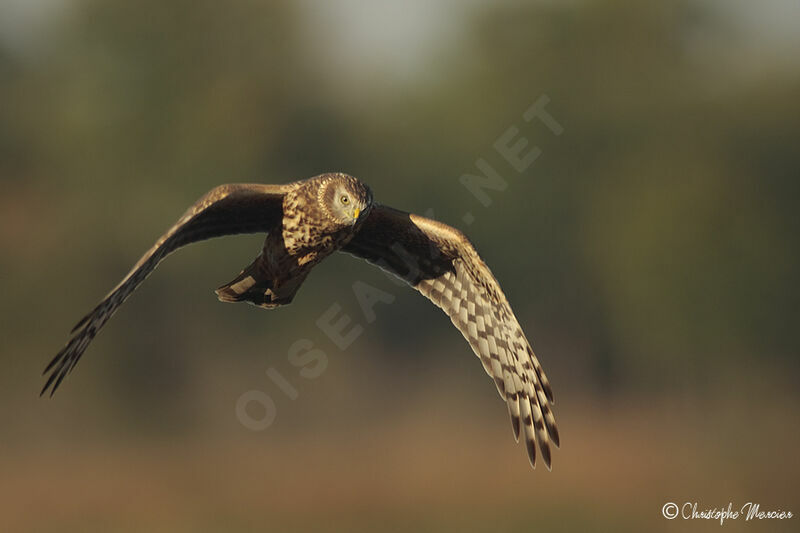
[319,173,372,226]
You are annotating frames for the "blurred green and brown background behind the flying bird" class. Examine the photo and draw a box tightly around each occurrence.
[0,0,800,531]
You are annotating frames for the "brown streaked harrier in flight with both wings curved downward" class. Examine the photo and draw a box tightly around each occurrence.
[41,173,559,469]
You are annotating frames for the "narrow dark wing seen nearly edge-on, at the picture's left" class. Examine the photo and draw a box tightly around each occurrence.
[41,184,292,396]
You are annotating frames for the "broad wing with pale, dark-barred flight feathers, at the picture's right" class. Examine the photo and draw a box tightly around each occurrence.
[343,205,559,469]
